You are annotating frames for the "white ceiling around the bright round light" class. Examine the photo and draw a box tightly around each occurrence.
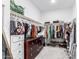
[31,0,75,11]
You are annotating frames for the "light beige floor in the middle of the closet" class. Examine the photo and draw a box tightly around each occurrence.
[35,46,69,59]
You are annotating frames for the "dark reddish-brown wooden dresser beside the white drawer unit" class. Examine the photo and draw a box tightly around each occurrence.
[24,37,44,59]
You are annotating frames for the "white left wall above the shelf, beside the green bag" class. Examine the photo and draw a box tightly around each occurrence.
[14,0,40,21]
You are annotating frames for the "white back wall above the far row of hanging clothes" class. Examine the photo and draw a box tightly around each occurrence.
[41,8,73,22]
